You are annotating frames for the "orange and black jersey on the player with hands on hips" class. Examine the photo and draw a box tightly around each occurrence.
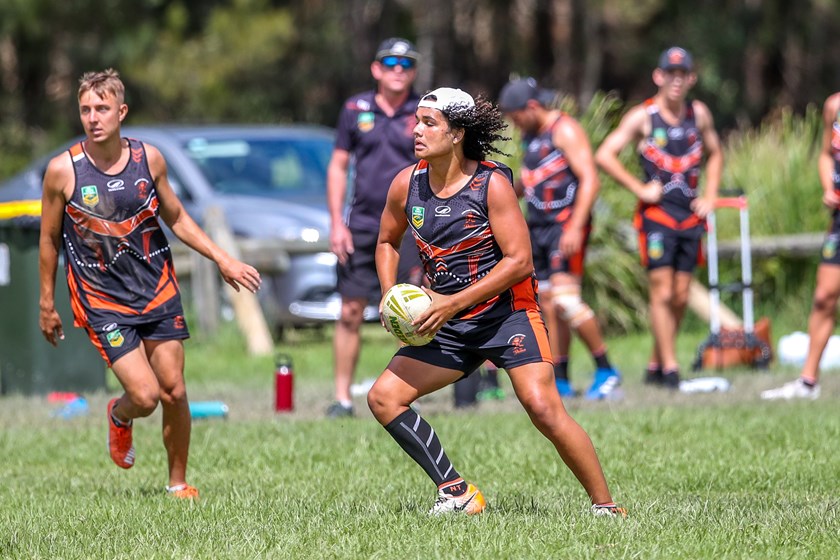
[640,99,703,221]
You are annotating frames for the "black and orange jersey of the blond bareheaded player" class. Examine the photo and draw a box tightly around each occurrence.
[62,139,183,326]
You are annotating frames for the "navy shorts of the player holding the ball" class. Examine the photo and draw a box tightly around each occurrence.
[396,309,552,376]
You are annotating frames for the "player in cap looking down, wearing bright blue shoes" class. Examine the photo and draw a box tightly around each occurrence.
[499,78,621,400]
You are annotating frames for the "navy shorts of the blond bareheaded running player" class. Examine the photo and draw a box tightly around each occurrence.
[85,315,190,367]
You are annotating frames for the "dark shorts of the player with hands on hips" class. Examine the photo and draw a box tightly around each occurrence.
[639,220,705,272]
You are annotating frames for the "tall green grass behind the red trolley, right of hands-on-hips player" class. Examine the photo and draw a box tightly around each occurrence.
[718,105,830,320]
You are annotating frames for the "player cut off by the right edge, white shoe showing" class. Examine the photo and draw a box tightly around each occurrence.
[761,92,840,400]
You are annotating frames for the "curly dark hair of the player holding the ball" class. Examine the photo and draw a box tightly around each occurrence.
[443,95,510,161]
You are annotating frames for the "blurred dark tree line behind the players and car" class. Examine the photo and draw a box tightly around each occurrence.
[0,0,840,178]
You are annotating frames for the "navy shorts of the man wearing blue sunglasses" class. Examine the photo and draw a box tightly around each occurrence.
[337,231,423,301]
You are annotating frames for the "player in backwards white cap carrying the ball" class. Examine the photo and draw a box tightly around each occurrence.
[368,88,624,516]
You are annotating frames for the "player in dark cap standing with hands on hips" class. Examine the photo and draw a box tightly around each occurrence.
[595,47,723,389]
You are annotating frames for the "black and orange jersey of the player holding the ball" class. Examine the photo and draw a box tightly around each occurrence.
[405,160,538,319]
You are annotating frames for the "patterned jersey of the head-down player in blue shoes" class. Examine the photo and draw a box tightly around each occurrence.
[521,114,578,226]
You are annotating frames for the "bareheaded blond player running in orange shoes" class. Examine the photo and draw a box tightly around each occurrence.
[39,69,260,498]
